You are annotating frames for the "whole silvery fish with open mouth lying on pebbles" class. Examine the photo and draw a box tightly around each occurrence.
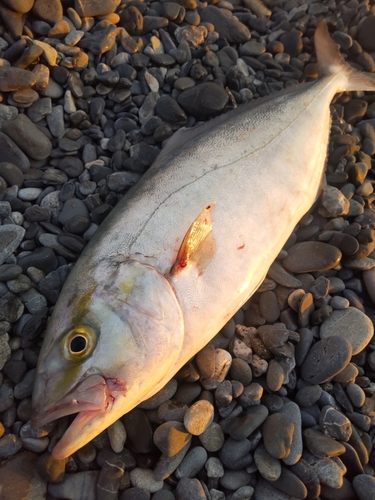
[32,22,375,459]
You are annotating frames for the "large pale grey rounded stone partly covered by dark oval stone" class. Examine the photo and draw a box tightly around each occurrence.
[320,307,374,356]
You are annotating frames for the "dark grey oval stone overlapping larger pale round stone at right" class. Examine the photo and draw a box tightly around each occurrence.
[301,337,352,384]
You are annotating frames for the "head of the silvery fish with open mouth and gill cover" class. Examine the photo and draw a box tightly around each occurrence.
[32,260,183,458]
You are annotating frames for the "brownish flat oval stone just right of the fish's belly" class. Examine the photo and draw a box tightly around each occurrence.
[282,241,341,273]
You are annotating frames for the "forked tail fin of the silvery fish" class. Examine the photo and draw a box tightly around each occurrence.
[314,21,375,92]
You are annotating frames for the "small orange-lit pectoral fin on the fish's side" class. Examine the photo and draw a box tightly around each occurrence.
[170,203,215,276]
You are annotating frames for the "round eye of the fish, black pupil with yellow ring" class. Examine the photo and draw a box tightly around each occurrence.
[62,325,96,361]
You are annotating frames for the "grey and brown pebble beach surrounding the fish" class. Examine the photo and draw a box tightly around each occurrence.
[0,0,375,500]
